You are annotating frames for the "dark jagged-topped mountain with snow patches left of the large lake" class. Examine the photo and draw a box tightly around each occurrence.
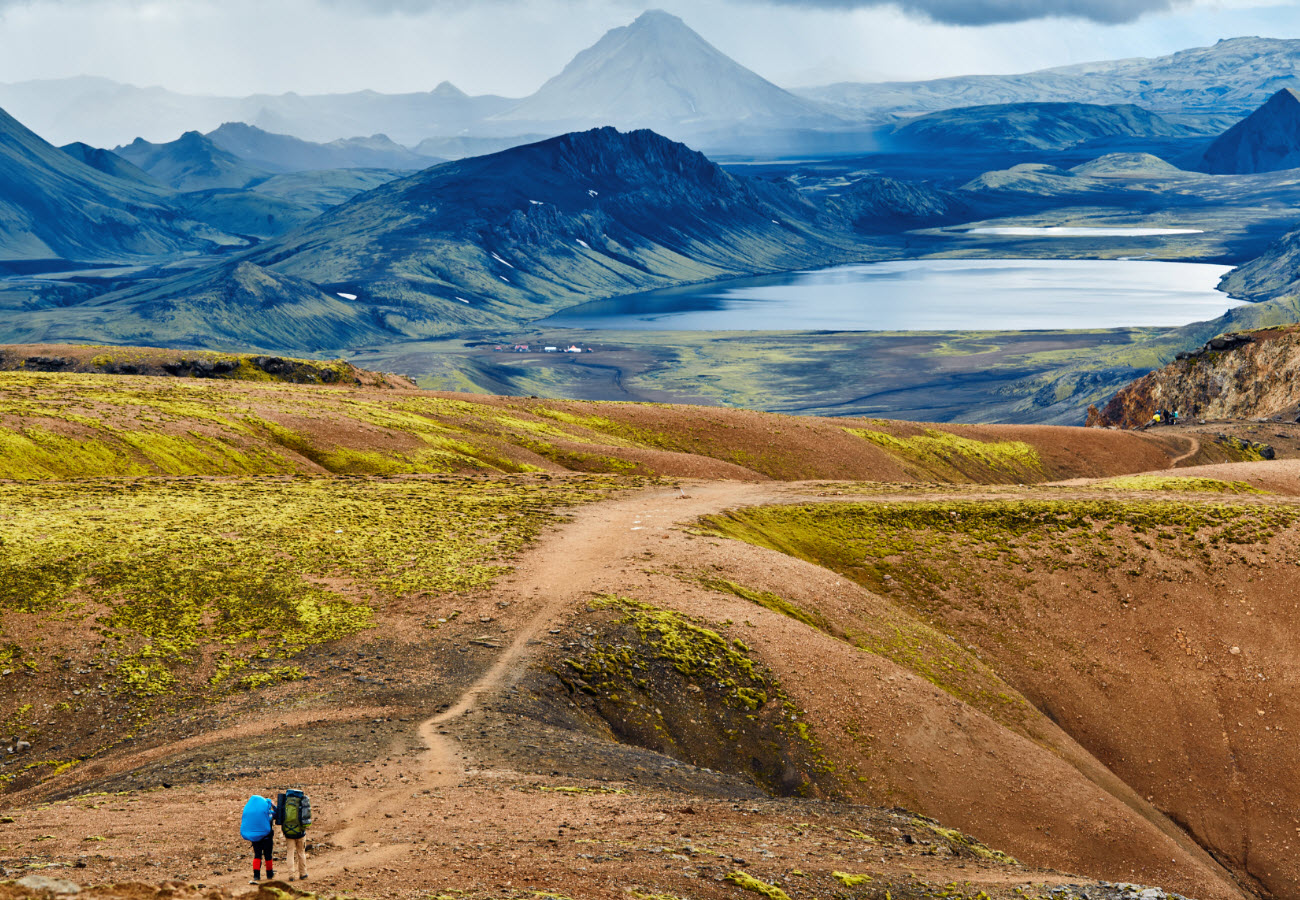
[233,127,855,334]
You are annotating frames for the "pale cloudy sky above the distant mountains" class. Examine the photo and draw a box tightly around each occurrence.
[0,0,1300,96]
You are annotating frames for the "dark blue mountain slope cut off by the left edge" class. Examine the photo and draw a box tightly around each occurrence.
[0,111,234,260]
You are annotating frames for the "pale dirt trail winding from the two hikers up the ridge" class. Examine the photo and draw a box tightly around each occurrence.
[311,483,788,875]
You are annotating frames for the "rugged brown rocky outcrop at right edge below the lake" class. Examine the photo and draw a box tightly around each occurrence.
[1087,325,1300,428]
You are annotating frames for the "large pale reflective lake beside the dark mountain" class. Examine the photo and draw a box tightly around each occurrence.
[536,259,1240,332]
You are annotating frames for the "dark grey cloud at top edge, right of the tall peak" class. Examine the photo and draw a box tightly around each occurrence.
[767,0,1191,25]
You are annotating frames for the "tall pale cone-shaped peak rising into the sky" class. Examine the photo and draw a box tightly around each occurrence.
[490,10,842,137]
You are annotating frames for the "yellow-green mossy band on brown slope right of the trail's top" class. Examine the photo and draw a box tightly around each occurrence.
[702,499,1300,598]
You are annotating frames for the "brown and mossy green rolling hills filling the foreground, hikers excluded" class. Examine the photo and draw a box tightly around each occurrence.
[0,366,1300,900]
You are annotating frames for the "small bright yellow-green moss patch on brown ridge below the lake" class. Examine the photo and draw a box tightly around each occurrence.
[845,428,1048,484]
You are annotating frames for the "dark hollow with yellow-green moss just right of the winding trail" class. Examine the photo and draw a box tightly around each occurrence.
[555,597,840,795]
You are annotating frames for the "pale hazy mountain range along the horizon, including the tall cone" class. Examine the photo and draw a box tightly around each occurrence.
[0,10,1300,154]
